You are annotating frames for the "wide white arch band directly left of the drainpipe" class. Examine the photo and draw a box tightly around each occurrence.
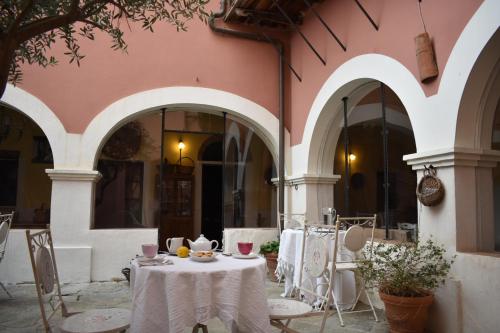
[80,87,288,169]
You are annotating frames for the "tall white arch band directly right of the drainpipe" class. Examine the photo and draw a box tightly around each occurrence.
[293,54,425,174]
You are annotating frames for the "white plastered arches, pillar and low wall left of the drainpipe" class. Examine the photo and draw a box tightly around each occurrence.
[0,85,289,283]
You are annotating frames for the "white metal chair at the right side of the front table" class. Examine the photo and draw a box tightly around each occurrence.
[268,224,335,333]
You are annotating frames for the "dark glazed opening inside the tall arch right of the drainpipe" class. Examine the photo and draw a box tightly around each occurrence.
[334,86,417,239]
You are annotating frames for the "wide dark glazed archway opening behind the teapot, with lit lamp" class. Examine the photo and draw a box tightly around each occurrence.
[87,87,277,246]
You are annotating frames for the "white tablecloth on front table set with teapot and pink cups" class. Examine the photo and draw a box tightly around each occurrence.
[130,254,270,333]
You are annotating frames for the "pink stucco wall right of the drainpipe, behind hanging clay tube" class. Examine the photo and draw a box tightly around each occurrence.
[289,0,482,145]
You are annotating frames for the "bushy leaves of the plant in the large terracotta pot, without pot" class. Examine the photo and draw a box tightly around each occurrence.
[358,239,454,297]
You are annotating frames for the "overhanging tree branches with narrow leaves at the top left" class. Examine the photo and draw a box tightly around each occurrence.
[0,0,209,84]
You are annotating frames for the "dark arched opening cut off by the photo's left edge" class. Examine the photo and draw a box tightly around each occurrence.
[0,104,54,228]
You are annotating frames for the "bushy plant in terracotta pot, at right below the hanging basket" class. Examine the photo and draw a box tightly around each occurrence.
[358,239,454,333]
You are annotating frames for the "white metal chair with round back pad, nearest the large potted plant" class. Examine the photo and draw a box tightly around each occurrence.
[333,214,378,326]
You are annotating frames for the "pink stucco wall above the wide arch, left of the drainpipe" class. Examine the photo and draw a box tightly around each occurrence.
[21,21,278,133]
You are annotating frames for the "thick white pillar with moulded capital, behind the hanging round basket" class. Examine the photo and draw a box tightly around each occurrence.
[404,148,500,251]
